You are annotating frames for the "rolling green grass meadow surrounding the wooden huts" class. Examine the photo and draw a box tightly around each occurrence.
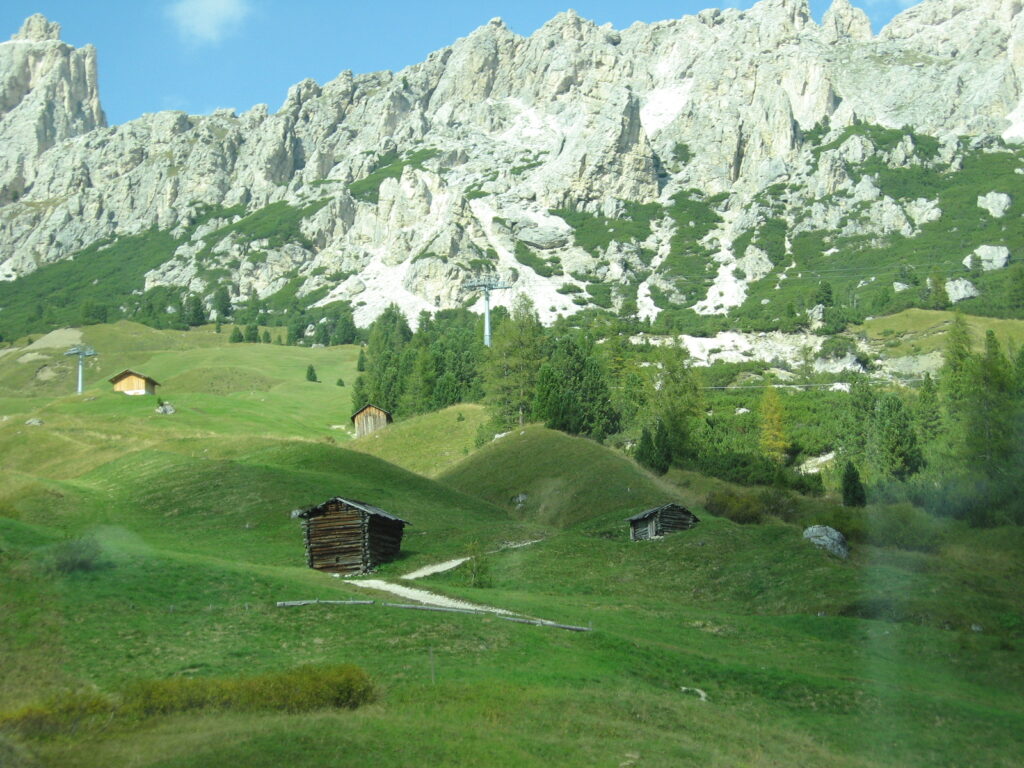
[0,318,1024,768]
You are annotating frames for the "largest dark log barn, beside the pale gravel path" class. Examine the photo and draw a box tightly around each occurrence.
[292,497,410,573]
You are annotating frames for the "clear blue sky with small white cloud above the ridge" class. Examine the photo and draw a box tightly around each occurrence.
[0,0,918,123]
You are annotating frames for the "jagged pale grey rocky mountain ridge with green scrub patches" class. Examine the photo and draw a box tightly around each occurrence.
[0,0,1024,325]
